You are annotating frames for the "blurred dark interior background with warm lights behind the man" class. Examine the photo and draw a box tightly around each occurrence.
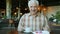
[0,0,60,34]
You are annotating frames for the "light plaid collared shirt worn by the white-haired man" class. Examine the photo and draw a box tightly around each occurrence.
[18,13,49,31]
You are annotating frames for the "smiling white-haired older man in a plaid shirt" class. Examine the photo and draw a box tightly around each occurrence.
[18,0,49,32]
